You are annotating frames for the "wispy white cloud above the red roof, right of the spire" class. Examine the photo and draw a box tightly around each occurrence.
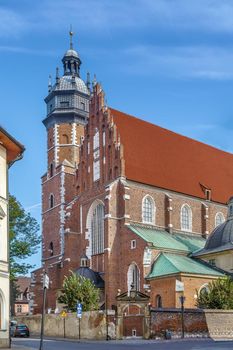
[121,45,233,80]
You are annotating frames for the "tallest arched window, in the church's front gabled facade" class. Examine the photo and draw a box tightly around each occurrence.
[91,204,104,255]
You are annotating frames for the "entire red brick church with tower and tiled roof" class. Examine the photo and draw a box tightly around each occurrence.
[32,34,233,313]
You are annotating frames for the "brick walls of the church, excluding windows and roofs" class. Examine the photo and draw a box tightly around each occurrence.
[35,85,227,314]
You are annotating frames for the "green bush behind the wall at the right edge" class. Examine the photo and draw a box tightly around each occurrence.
[197,276,233,310]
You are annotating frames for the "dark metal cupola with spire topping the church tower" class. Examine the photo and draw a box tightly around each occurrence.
[43,31,90,129]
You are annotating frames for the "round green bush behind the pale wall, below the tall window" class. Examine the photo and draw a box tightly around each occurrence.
[58,271,99,311]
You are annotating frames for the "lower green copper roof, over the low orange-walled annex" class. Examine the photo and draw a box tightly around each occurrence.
[147,253,223,278]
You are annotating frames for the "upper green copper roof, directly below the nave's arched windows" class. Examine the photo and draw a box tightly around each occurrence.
[128,225,206,253]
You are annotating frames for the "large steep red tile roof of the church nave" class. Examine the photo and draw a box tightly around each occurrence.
[110,108,233,203]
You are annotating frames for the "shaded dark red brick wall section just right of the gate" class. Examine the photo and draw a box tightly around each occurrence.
[151,309,208,337]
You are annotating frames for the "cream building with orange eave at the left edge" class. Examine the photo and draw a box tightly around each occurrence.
[0,127,24,348]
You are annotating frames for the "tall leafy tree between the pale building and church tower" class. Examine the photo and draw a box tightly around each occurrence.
[9,195,41,280]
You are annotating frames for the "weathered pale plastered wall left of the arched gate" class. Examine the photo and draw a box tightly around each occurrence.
[16,310,115,339]
